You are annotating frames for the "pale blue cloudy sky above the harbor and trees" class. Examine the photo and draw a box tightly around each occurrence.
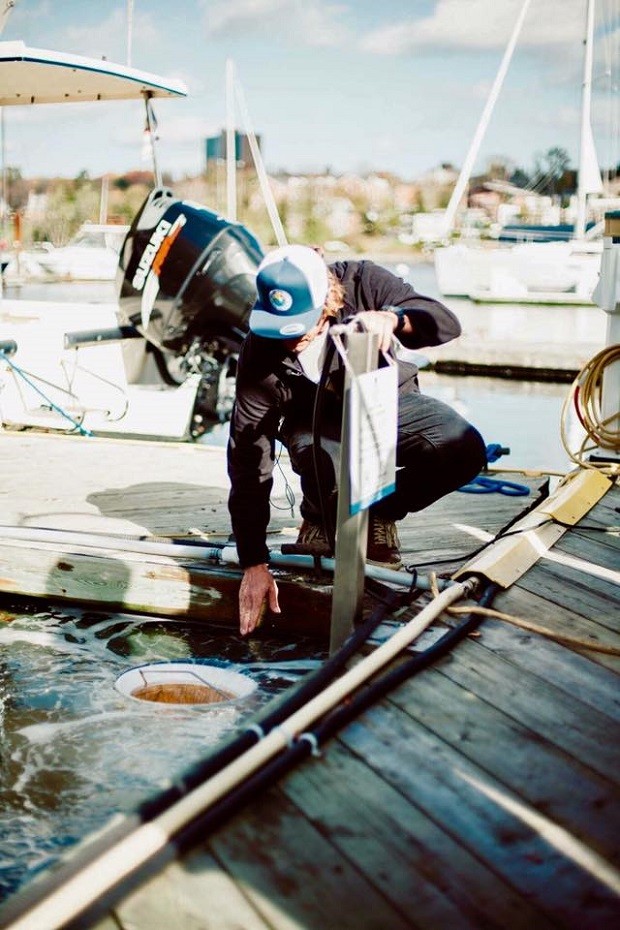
[0,0,620,180]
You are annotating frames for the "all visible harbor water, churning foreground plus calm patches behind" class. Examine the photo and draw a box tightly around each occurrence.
[0,264,597,899]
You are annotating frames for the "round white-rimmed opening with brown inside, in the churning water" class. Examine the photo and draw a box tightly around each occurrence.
[116,662,257,705]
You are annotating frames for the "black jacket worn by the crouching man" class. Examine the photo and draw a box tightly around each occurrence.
[228,261,461,568]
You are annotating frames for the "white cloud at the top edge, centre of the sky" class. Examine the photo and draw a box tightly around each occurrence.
[202,0,346,46]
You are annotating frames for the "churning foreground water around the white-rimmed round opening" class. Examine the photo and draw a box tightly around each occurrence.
[0,600,325,902]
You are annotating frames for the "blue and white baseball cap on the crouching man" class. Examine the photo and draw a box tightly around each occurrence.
[249,245,329,339]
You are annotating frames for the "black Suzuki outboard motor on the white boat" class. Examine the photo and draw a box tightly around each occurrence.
[117,188,264,432]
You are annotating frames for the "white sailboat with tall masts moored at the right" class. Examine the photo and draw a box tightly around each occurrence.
[435,0,603,304]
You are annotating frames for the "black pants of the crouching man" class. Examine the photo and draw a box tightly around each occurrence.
[282,393,486,524]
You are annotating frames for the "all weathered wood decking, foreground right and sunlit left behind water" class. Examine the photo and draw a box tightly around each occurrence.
[0,434,620,930]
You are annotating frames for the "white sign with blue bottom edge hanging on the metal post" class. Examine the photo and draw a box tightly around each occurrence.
[349,365,398,514]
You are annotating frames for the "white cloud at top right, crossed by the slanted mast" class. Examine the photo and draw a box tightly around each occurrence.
[361,0,585,55]
